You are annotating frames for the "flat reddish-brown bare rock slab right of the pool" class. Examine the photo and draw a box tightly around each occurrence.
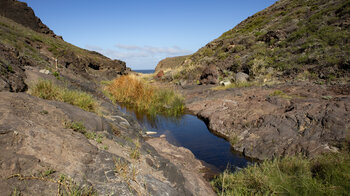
[182,82,350,160]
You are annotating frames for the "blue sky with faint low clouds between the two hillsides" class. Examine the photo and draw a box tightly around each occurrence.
[21,0,276,70]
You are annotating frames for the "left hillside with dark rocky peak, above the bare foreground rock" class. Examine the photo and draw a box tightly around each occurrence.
[0,0,126,92]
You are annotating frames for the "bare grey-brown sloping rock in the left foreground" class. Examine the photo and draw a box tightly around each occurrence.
[0,92,208,195]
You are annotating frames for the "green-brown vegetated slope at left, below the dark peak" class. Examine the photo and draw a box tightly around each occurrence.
[0,16,125,77]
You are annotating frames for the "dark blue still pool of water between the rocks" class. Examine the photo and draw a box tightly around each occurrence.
[121,104,248,170]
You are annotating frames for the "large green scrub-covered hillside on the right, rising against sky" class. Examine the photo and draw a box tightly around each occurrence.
[161,0,350,81]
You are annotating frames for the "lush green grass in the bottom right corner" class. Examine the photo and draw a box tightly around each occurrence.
[211,152,350,195]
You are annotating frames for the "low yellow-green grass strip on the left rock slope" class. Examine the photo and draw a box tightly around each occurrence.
[31,80,98,113]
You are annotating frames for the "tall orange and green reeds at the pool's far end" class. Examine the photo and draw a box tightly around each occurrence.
[106,76,184,116]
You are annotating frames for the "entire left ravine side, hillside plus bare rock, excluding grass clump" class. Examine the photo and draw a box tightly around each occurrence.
[0,0,214,195]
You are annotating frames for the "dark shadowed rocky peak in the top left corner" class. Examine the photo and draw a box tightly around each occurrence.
[0,0,57,37]
